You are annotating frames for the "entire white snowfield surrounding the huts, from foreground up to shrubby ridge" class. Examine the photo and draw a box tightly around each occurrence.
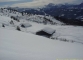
[0,9,83,60]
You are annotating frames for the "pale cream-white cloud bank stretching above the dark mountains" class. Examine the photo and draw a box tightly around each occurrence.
[4,0,82,8]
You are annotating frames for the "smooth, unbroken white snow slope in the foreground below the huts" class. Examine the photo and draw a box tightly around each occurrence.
[0,28,83,60]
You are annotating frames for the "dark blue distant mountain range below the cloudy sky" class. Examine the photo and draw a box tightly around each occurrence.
[5,3,83,25]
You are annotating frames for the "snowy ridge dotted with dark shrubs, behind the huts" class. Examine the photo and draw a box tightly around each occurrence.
[0,9,64,25]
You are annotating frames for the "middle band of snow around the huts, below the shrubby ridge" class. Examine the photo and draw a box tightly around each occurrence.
[0,16,83,44]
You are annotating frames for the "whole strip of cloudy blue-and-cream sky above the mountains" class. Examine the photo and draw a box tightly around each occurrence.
[0,0,83,8]
